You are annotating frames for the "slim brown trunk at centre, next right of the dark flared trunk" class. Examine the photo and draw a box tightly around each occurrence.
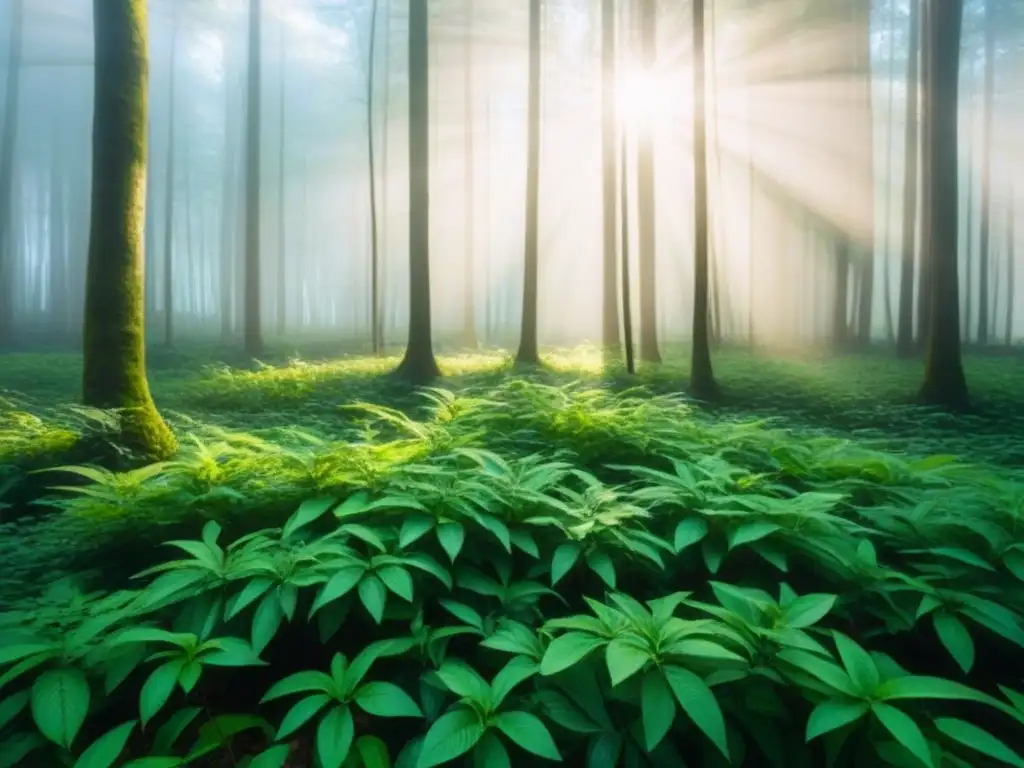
[516,0,541,365]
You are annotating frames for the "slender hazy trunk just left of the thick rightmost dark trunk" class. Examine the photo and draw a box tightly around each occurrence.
[896,0,923,357]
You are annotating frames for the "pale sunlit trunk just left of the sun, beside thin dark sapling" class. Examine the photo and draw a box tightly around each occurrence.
[601,0,620,350]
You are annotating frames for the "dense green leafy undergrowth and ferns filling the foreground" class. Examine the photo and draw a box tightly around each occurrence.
[0,353,1024,768]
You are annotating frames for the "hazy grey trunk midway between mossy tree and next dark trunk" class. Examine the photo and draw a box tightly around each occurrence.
[242,0,263,357]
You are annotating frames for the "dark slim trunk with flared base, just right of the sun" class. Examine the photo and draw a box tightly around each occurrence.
[690,0,718,399]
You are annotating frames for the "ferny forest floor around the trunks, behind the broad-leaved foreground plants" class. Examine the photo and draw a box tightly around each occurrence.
[0,346,1024,765]
